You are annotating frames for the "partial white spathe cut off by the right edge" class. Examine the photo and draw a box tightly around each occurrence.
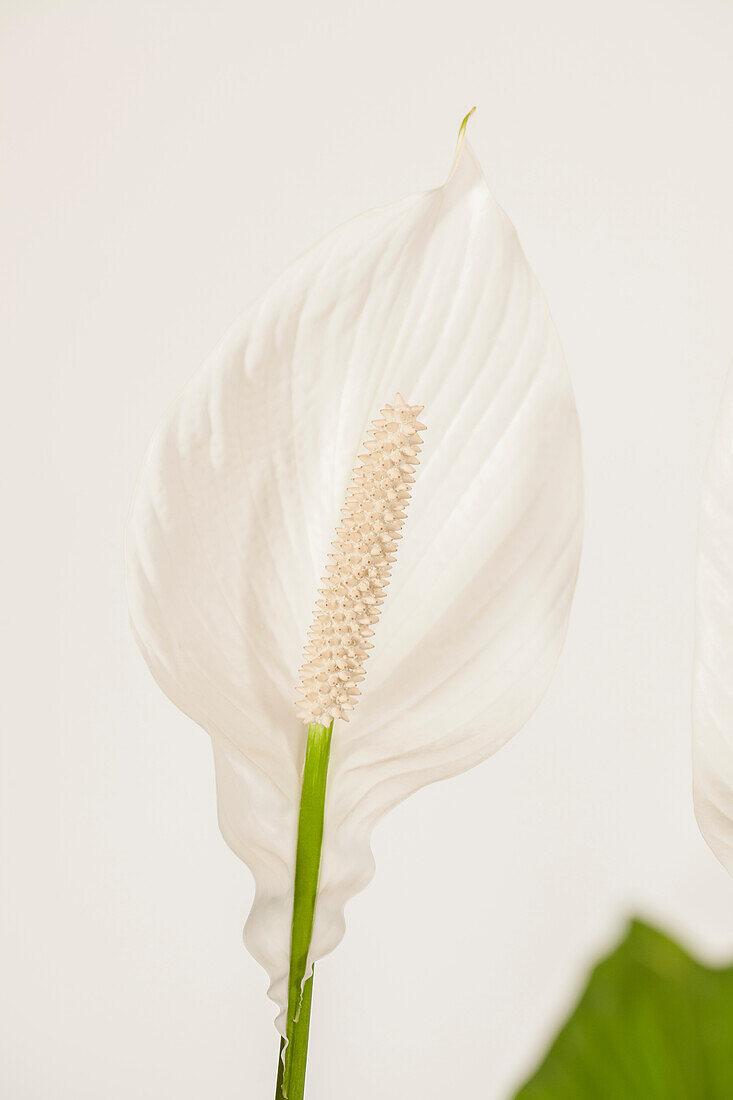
[692,367,733,875]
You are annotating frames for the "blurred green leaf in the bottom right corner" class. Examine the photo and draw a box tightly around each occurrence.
[515,921,733,1100]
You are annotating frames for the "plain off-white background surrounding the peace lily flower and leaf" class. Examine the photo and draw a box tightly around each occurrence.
[0,0,733,1100]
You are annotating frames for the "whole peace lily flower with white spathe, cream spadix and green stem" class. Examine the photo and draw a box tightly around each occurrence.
[128,113,581,1100]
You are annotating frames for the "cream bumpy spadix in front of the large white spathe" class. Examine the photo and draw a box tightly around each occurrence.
[297,394,425,726]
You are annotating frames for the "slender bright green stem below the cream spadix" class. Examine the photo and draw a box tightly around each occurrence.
[275,722,333,1100]
